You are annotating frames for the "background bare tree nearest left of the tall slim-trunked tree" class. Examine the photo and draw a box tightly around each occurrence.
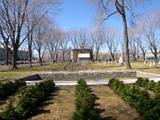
[105,29,119,61]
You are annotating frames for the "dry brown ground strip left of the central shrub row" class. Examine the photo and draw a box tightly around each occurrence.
[31,87,75,120]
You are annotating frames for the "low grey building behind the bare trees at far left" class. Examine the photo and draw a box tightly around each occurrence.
[0,47,28,64]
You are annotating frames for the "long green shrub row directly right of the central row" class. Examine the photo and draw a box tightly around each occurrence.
[109,79,160,120]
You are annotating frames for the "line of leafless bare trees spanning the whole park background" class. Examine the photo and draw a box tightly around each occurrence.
[0,0,160,69]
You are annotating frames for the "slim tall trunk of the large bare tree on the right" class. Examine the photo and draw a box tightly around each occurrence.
[122,13,131,69]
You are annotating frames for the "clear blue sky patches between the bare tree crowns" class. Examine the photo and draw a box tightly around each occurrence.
[56,0,160,31]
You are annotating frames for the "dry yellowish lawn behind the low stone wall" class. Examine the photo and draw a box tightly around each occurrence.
[0,62,160,80]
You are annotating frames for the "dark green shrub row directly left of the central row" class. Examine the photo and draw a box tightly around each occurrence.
[0,80,55,120]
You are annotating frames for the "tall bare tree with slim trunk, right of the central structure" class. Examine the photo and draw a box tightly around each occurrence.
[93,0,148,69]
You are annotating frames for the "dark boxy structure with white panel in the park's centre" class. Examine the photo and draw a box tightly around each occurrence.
[71,49,93,63]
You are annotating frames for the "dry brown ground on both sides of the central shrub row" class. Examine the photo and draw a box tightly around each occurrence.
[31,86,140,120]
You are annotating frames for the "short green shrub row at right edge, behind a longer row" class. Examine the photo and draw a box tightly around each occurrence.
[136,78,160,93]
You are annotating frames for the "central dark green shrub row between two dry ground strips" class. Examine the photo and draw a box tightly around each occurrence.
[72,79,101,120]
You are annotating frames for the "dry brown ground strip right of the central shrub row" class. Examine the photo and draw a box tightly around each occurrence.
[91,85,140,120]
